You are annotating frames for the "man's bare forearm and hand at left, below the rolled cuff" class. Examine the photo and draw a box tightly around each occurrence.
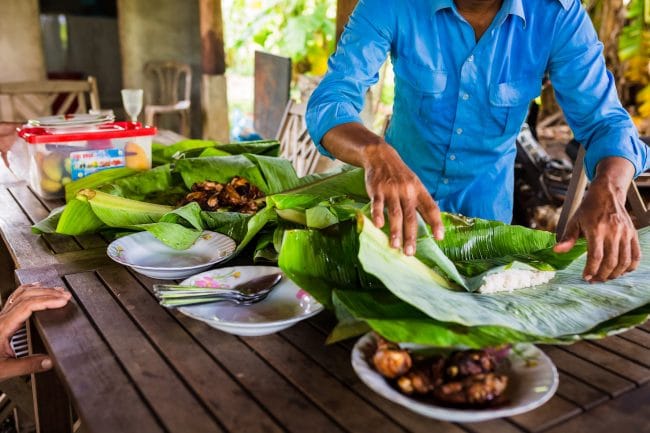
[322,123,444,255]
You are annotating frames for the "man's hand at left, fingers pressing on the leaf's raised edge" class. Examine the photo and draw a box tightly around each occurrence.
[363,142,444,256]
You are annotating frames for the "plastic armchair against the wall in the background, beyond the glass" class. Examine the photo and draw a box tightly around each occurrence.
[144,61,192,136]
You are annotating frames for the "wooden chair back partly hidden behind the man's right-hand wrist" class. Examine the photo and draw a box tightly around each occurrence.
[556,146,650,238]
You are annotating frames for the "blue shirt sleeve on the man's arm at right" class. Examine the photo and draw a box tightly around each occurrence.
[549,1,648,179]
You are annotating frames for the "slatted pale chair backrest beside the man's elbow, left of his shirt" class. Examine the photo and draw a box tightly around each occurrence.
[276,100,340,176]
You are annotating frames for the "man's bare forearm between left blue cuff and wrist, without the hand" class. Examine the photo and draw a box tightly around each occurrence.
[322,122,394,168]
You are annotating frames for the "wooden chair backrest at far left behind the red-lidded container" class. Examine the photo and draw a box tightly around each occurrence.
[0,77,100,122]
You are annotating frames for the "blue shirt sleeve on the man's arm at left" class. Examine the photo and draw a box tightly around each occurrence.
[306,0,396,157]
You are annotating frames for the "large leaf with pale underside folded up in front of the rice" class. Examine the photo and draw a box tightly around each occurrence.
[359,217,650,338]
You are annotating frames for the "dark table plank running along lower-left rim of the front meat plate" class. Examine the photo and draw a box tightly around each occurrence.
[282,322,463,433]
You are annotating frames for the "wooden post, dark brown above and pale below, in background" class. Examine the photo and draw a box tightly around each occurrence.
[199,0,230,142]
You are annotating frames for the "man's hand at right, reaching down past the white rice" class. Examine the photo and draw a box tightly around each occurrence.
[554,157,641,281]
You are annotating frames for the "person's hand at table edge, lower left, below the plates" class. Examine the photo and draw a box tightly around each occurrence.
[0,283,71,381]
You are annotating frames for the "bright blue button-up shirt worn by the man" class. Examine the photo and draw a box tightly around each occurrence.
[307,0,646,222]
